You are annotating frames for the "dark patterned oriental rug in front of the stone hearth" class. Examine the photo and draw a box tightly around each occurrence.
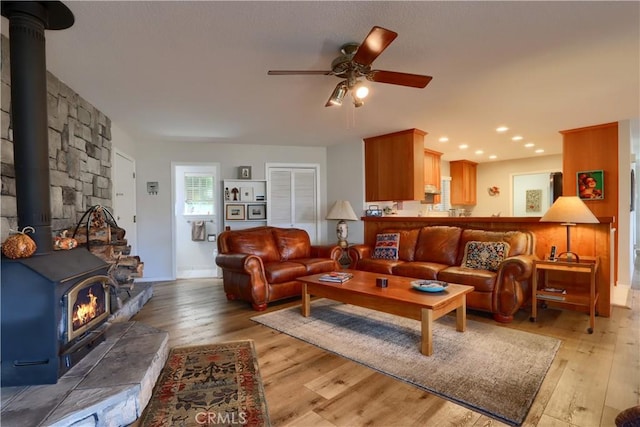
[140,340,270,427]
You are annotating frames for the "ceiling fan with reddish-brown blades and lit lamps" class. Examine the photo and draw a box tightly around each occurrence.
[267,26,432,107]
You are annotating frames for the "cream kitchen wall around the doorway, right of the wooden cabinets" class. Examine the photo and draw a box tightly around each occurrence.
[472,154,562,217]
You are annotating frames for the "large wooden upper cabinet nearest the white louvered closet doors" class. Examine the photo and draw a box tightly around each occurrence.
[364,129,428,202]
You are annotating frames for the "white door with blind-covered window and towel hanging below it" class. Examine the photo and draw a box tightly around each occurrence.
[173,163,222,279]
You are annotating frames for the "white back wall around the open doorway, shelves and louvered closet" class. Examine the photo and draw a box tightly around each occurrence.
[136,141,327,281]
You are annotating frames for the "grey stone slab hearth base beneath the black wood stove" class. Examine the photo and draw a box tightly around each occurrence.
[1,284,169,427]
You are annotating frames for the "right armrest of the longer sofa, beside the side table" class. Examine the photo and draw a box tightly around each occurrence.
[493,255,537,322]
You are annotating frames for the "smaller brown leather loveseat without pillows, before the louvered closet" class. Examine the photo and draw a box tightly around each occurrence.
[216,226,342,311]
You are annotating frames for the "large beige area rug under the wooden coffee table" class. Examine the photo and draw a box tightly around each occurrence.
[252,299,560,425]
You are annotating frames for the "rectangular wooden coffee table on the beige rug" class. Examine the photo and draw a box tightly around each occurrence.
[297,270,473,356]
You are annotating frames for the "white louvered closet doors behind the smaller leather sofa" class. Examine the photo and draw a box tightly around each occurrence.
[267,168,319,243]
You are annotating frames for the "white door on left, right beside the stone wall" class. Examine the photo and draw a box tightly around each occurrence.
[113,150,137,255]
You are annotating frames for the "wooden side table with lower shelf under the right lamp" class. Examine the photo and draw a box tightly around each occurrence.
[529,257,600,334]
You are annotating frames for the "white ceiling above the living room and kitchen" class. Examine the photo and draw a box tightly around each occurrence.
[2,1,640,162]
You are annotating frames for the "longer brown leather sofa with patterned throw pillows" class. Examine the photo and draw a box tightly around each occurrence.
[349,226,536,323]
